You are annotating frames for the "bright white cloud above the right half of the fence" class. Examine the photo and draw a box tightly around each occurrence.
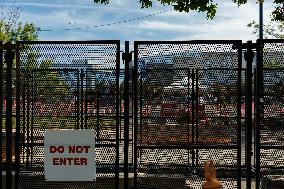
[134,2,272,41]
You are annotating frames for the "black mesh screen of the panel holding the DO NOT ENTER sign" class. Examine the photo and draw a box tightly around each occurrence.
[15,41,119,188]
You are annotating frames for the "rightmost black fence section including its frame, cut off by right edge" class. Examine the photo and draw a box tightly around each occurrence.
[255,40,284,188]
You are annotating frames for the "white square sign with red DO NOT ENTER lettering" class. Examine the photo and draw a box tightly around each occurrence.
[44,130,96,181]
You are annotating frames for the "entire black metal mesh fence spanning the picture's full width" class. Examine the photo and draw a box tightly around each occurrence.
[0,40,284,189]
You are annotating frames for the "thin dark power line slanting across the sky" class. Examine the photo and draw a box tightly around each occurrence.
[37,9,172,32]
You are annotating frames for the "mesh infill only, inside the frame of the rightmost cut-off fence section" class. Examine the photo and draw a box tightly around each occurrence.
[256,40,284,187]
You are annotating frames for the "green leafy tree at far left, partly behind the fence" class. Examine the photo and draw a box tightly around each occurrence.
[0,5,70,99]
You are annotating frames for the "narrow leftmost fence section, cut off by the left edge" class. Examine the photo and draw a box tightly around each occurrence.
[0,44,16,189]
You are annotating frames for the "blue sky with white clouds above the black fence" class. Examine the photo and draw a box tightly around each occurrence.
[0,0,273,42]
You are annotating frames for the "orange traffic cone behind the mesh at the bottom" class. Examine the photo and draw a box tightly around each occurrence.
[203,160,222,189]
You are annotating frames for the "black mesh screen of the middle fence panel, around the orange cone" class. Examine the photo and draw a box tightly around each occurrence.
[135,41,241,188]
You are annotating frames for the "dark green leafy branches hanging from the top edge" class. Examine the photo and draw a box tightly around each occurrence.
[94,0,284,21]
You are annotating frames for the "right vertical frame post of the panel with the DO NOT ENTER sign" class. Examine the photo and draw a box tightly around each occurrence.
[115,42,120,188]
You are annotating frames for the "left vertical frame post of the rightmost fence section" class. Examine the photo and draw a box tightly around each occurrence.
[254,40,263,189]
